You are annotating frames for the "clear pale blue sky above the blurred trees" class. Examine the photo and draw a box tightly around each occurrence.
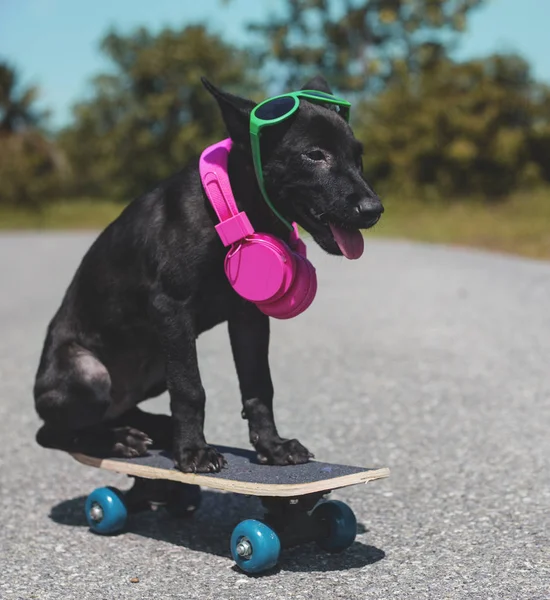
[0,0,550,125]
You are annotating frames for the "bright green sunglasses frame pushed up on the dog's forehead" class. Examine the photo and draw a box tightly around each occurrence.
[250,90,351,231]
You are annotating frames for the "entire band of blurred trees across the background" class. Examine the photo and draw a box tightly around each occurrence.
[0,0,550,210]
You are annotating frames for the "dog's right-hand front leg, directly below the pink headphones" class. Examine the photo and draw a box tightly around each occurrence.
[229,305,313,465]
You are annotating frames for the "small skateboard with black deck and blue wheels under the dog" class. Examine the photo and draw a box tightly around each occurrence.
[71,446,390,573]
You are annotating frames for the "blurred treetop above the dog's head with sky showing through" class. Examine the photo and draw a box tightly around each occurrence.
[251,0,483,93]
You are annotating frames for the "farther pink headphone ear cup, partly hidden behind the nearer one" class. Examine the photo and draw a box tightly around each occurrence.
[257,254,317,319]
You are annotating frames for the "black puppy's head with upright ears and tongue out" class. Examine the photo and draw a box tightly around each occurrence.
[203,77,384,258]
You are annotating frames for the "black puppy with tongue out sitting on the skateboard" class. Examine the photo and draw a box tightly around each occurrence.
[34,77,383,471]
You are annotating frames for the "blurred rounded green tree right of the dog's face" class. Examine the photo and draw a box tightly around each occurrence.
[356,55,550,199]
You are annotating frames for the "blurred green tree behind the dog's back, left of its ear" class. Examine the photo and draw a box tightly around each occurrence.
[61,26,264,199]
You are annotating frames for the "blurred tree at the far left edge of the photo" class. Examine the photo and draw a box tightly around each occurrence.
[0,62,67,208]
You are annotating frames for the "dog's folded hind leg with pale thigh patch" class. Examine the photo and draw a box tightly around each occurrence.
[34,343,151,456]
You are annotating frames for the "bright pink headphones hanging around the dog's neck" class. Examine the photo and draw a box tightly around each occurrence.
[199,138,317,319]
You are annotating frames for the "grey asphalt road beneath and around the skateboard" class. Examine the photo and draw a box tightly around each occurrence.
[0,234,550,600]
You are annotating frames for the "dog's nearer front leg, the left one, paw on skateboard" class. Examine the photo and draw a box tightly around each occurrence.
[153,294,225,473]
